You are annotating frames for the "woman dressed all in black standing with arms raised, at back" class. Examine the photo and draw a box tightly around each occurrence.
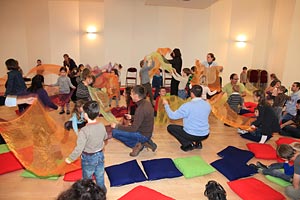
[168,48,182,96]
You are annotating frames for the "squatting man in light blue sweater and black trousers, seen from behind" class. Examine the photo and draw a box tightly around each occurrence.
[163,85,211,151]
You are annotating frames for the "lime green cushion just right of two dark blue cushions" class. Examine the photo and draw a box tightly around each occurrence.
[173,156,216,178]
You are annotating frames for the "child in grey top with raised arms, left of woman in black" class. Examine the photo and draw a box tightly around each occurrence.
[140,57,155,106]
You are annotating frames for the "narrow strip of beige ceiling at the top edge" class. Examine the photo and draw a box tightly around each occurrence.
[145,0,218,9]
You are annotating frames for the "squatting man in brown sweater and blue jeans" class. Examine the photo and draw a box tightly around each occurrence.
[111,85,157,156]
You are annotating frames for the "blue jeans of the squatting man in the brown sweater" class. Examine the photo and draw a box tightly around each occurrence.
[112,128,150,148]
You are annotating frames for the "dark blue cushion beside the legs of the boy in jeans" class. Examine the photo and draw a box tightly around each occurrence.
[105,160,147,187]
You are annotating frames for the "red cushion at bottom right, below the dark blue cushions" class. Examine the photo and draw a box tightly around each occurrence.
[227,178,285,200]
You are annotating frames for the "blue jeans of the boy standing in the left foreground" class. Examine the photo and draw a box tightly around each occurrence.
[81,151,106,191]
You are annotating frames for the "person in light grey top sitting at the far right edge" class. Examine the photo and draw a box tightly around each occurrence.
[281,82,300,123]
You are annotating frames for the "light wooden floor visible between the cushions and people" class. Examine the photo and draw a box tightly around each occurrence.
[0,97,284,200]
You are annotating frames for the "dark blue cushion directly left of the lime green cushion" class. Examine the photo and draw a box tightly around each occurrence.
[142,158,182,180]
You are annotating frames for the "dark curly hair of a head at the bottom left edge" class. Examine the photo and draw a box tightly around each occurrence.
[57,179,106,200]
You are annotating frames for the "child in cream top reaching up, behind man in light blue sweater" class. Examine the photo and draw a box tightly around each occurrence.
[172,68,191,99]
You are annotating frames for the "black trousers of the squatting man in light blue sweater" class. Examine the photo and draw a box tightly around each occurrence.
[167,124,208,146]
